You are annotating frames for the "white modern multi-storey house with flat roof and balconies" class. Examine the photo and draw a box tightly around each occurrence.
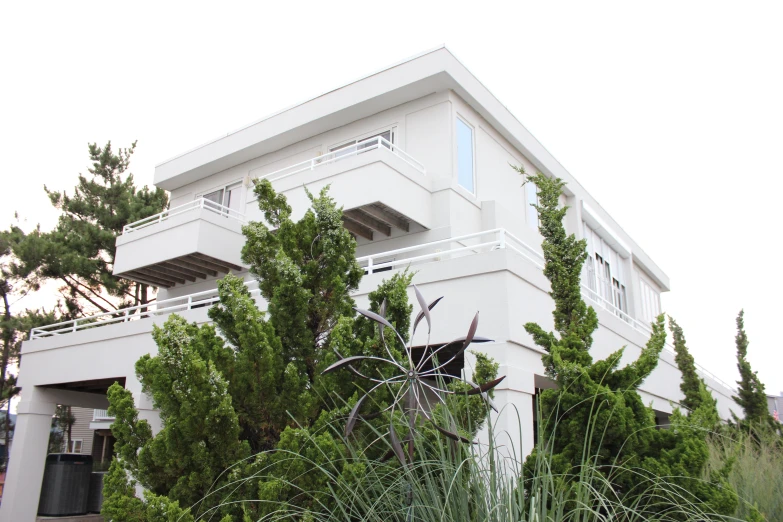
[0,48,732,522]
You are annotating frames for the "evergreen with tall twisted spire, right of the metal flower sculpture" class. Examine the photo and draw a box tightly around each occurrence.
[517,168,737,514]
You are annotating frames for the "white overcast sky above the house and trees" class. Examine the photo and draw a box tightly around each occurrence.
[0,0,783,393]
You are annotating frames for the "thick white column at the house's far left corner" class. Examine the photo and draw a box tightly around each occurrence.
[0,389,56,522]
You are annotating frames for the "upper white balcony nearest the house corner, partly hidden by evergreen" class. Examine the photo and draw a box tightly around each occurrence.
[254,136,432,241]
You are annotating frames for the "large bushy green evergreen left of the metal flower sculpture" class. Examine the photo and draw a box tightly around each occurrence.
[104,181,497,520]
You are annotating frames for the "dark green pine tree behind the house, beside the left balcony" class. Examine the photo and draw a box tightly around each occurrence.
[13,142,168,316]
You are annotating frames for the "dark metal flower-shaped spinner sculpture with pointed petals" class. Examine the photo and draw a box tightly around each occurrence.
[323,285,505,465]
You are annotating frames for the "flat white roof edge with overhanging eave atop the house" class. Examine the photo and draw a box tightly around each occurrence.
[154,46,669,290]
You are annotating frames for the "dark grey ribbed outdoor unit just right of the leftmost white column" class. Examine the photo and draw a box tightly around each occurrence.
[38,453,92,517]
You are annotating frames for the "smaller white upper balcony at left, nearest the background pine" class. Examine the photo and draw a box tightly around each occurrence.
[114,198,245,288]
